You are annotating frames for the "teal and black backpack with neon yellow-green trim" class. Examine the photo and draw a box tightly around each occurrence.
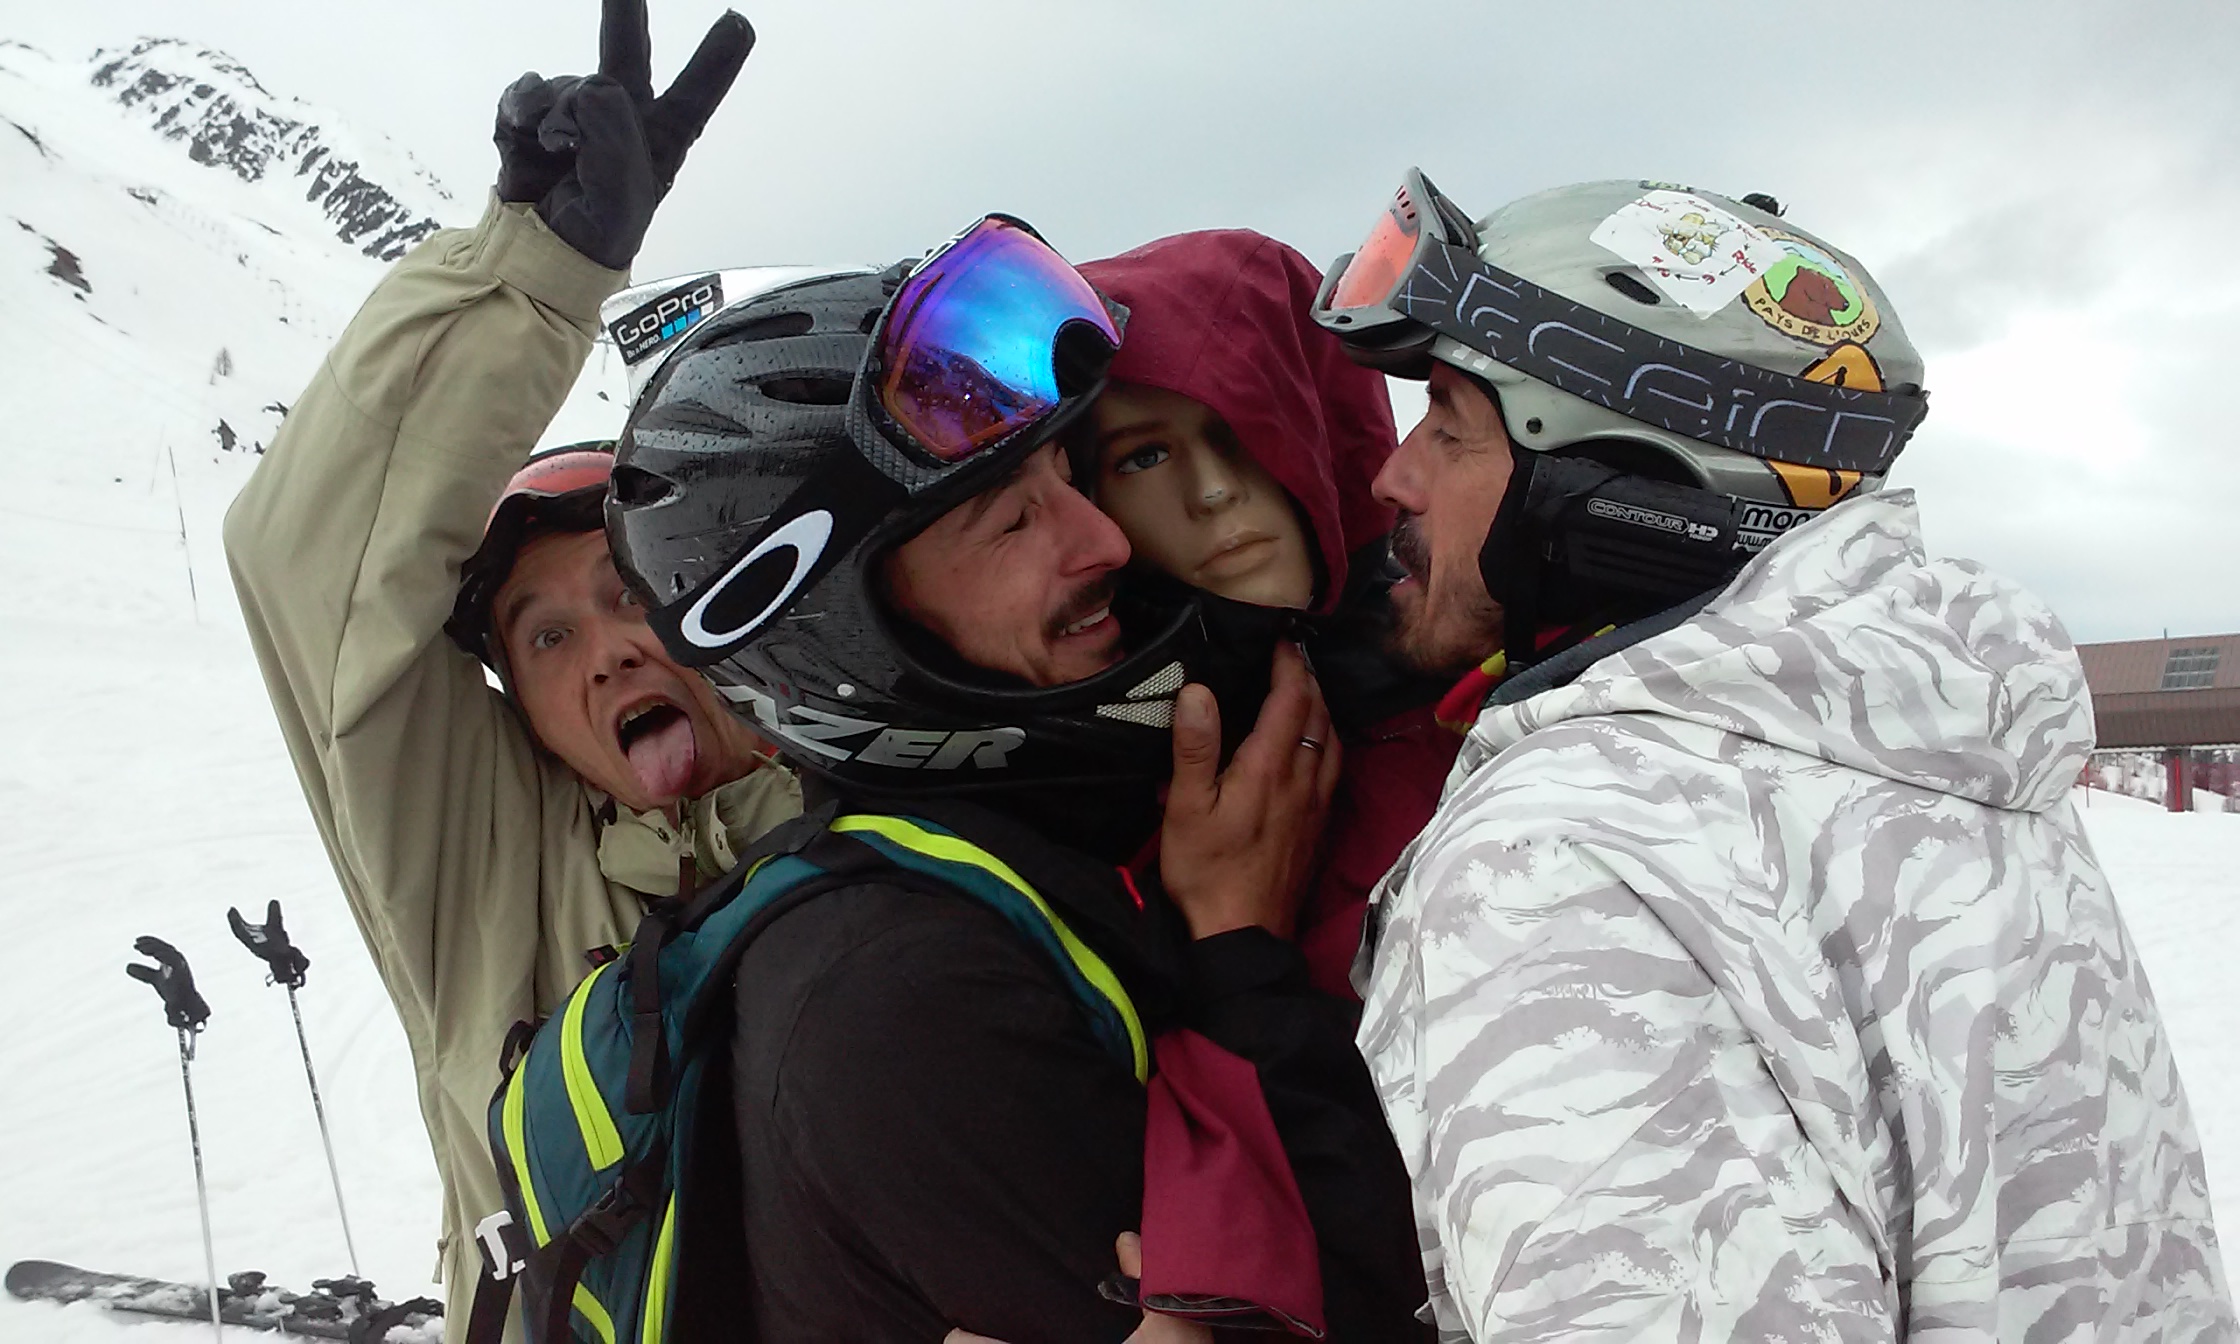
[466,806,1149,1344]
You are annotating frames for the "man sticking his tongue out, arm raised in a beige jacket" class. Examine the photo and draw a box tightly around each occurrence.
[226,0,797,1324]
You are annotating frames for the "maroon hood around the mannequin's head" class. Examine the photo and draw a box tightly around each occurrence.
[1080,228,1398,609]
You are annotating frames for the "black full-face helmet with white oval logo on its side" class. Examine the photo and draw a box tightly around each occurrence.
[607,269,1198,795]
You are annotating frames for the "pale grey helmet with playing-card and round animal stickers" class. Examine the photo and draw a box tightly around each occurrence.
[1317,175,1926,537]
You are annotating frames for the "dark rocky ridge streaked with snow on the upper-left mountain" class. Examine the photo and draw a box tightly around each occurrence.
[90,38,450,260]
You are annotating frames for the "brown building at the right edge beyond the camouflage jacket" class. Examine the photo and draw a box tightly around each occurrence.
[2076,634,2240,811]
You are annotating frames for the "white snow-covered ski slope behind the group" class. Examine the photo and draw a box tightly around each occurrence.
[0,28,2240,1344]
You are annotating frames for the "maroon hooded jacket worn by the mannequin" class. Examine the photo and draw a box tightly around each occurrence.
[1082,228,1460,1335]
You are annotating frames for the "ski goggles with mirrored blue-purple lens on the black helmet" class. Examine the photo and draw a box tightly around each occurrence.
[853,215,1124,491]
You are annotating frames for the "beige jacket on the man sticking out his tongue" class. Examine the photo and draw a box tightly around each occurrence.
[226,202,800,1337]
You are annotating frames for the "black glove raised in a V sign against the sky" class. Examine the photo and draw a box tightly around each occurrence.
[495,0,755,271]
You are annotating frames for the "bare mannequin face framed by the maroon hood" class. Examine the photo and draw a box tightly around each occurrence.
[1091,383,1315,607]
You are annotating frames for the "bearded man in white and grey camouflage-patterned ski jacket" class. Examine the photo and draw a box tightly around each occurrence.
[1317,172,2240,1342]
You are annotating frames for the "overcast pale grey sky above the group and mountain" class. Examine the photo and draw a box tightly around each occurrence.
[17,0,2240,641]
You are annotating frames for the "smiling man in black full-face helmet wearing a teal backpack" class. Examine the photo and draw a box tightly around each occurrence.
[609,215,1425,1344]
